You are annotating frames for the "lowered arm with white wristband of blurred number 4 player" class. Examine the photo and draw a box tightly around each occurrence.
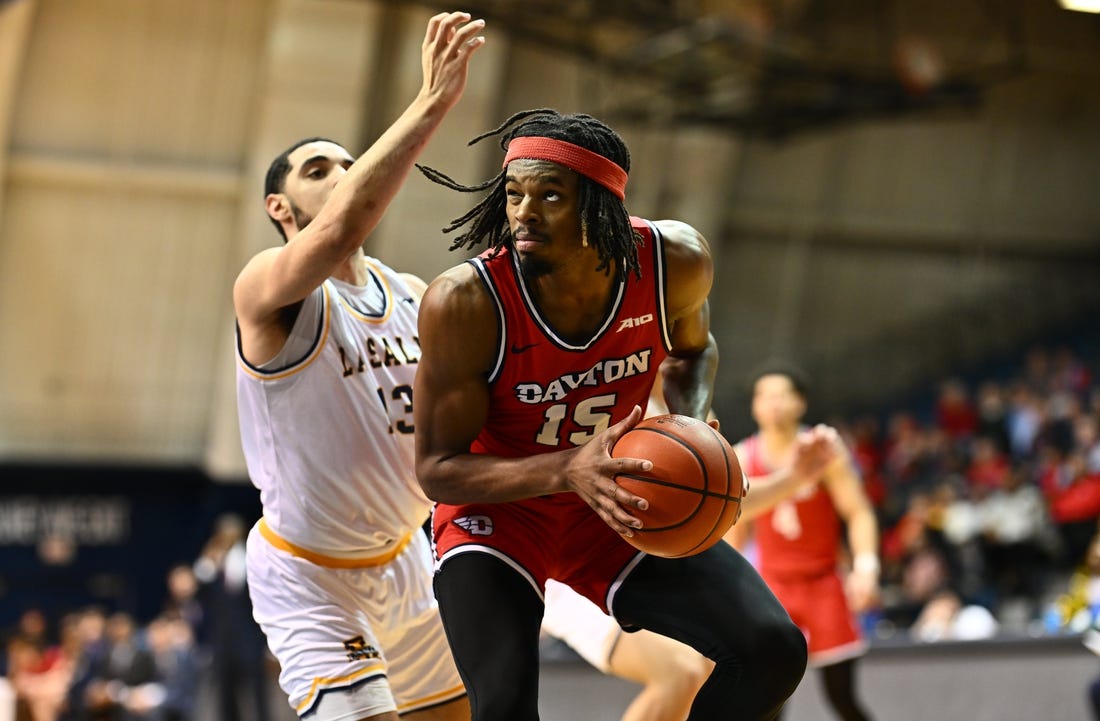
[823,440,880,612]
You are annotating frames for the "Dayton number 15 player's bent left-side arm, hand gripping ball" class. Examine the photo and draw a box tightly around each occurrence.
[413,263,651,535]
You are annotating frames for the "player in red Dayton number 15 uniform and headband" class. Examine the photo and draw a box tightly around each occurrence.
[415,110,821,721]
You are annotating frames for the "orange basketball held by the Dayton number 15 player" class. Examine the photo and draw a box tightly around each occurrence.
[612,414,745,558]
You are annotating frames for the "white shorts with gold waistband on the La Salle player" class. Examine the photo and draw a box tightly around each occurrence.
[248,522,465,721]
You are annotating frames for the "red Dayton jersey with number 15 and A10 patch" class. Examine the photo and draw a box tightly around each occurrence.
[469,218,670,457]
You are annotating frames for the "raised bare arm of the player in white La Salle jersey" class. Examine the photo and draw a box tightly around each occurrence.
[233,12,484,362]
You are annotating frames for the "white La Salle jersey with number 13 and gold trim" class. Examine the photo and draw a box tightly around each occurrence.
[237,259,431,558]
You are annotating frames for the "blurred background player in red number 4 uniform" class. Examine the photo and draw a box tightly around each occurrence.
[726,363,879,721]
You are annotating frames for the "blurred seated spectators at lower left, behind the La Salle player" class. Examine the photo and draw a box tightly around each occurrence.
[0,514,272,721]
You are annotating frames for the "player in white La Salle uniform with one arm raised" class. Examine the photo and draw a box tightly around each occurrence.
[233,12,484,721]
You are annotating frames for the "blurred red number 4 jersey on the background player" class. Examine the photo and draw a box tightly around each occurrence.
[741,436,840,578]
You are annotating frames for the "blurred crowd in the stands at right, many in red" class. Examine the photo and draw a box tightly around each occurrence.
[832,347,1100,638]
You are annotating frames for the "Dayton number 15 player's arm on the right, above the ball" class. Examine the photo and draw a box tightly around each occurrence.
[656,220,718,420]
